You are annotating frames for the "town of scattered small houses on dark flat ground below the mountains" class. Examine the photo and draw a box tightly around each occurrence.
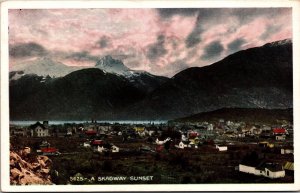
[10,119,294,184]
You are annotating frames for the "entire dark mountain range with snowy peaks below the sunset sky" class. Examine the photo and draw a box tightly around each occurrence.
[9,40,293,120]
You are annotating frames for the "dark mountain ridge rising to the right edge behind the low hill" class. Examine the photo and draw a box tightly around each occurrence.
[120,38,293,119]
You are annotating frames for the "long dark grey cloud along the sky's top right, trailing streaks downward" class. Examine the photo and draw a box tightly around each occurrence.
[182,8,290,48]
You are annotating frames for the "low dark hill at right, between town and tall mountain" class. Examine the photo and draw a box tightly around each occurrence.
[174,108,293,124]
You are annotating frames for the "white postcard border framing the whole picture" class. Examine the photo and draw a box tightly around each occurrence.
[1,0,300,192]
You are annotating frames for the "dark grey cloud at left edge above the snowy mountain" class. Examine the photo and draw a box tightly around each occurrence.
[9,42,47,58]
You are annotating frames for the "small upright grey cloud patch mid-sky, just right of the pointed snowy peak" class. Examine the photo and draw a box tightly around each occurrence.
[147,35,167,61]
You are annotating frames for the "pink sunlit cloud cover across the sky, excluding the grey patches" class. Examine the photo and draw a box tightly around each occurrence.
[9,9,292,76]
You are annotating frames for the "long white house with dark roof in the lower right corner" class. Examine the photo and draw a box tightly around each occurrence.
[239,162,285,178]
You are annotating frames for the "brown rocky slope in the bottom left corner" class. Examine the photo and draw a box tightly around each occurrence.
[10,148,52,185]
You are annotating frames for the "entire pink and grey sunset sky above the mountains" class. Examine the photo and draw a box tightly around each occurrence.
[9,8,292,76]
